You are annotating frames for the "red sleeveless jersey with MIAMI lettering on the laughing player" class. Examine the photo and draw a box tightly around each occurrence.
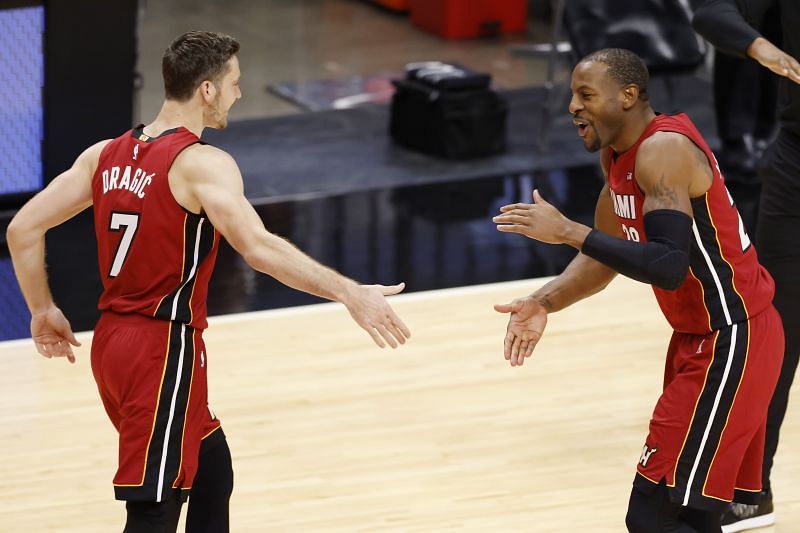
[608,114,775,334]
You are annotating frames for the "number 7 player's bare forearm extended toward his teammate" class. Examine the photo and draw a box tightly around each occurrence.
[242,233,357,303]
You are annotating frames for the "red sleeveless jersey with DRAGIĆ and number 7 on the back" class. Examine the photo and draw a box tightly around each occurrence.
[92,126,219,329]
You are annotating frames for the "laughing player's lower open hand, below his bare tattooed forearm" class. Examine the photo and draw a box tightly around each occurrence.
[494,296,547,366]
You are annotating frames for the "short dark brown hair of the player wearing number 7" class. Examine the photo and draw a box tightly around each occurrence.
[161,31,239,102]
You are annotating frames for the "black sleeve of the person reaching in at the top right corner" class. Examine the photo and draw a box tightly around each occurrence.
[692,0,774,57]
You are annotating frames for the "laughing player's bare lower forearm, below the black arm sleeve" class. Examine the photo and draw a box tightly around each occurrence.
[531,253,617,313]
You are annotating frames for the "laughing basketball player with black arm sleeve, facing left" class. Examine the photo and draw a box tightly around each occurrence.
[494,49,783,532]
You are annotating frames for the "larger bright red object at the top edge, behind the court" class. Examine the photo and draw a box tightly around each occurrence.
[411,0,528,39]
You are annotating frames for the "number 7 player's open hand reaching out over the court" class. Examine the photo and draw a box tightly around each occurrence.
[343,283,411,348]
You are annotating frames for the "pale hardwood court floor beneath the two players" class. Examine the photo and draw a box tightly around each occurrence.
[0,279,800,533]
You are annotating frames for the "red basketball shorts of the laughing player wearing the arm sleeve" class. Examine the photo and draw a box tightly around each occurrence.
[634,306,784,509]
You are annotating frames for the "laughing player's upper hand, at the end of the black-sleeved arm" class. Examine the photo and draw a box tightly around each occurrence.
[492,190,571,244]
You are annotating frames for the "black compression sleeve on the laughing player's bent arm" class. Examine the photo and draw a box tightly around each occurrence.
[581,209,692,291]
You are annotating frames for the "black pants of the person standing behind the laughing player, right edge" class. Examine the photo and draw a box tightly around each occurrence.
[756,130,800,490]
